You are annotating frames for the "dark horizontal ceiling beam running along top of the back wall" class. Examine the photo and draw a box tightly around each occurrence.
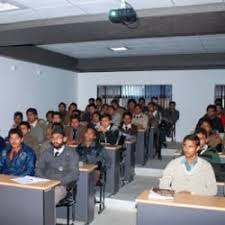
[77,54,225,72]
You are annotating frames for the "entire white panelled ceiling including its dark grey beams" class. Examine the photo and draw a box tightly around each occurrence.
[0,0,225,72]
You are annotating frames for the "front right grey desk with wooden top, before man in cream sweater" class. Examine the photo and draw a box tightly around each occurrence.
[136,190,225,225]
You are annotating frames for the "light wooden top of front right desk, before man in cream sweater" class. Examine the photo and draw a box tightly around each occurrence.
[136,190,225,212]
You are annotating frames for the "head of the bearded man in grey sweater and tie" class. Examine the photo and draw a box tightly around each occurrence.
[51,123,66,149]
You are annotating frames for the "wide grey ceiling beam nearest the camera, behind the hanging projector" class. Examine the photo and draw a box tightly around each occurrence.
[0,4,225,46]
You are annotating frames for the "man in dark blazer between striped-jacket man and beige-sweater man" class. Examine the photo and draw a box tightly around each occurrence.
[119,112,138,138]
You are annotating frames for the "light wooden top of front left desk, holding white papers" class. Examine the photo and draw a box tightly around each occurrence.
[0,175,61,191]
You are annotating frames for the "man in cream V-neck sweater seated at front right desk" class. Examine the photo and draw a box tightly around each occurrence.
[159,134,217,196]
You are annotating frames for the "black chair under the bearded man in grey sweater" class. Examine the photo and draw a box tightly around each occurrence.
[56,182,77,225]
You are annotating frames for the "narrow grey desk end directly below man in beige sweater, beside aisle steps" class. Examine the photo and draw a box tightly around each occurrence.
[135,129,147,165]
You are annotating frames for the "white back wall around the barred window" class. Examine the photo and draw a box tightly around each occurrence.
[77,70,225,141]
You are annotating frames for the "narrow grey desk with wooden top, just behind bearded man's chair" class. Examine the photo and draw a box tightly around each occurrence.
[57,164,97,224]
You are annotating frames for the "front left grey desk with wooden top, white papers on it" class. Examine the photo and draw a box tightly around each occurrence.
[0,175,60,225]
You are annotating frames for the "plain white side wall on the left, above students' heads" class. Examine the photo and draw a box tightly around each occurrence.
[0,57,77,136]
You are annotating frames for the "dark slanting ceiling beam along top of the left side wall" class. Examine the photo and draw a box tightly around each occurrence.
[0,46,78,71]
